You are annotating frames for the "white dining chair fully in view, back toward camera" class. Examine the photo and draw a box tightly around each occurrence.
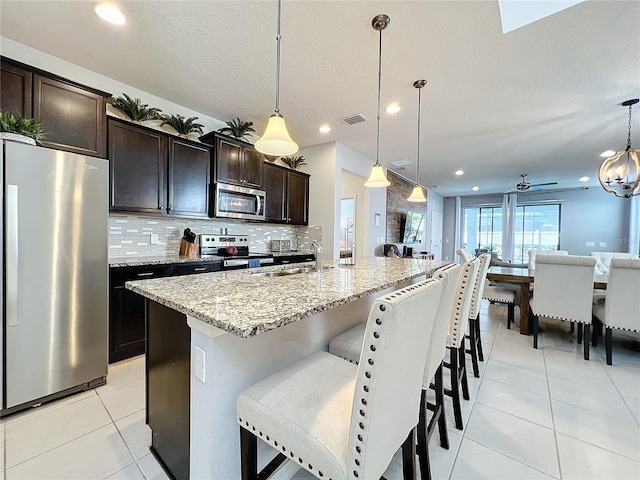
[529,255,596,360]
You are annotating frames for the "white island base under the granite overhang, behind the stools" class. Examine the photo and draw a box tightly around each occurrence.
[188,277,416,479]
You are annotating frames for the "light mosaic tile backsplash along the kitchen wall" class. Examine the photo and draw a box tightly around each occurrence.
[109,213,322,258]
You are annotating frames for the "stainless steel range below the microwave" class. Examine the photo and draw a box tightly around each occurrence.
[199,233,275,270]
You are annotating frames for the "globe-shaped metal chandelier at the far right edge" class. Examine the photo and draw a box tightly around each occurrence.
[598,98,640,198]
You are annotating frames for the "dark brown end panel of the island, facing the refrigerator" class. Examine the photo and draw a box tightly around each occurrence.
[146,300,191,480]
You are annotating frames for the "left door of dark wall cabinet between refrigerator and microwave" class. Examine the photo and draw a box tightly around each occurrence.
[108,118,167,213]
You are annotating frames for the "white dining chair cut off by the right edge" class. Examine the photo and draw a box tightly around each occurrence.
[585,258,640,365]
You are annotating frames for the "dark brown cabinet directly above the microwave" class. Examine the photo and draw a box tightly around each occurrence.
[200,132,264,188]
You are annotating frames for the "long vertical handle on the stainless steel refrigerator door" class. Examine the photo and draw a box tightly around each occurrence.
[5,185,18,327]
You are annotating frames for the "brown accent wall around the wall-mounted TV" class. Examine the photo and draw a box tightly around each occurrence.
[385,170,429,245]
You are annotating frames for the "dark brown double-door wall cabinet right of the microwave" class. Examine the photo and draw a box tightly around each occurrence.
[263,163,309,225]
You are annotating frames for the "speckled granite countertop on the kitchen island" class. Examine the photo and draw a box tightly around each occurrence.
[125,257,450,338]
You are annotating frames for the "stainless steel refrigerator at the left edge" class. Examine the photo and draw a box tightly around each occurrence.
[0,141,109,415]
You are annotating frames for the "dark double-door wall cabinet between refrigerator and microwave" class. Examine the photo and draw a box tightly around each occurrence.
[108,118,211,218]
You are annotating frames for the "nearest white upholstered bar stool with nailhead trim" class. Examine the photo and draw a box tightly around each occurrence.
[236,279,443,480]
